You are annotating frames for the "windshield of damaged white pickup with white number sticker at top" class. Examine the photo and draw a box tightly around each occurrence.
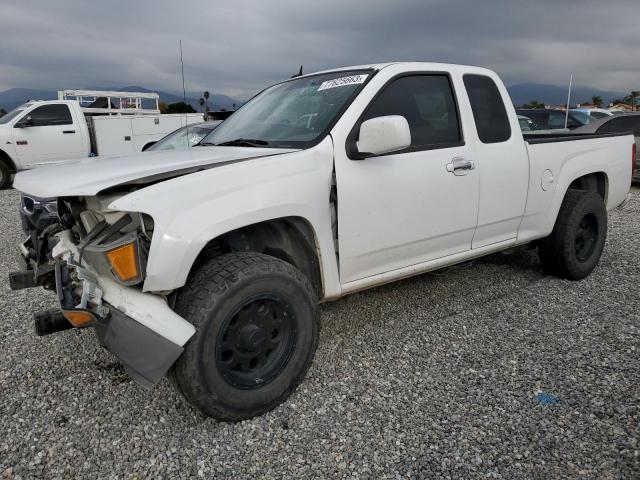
[200,70,372,148]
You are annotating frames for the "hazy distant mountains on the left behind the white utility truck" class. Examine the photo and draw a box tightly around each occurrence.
[0,85,243,112]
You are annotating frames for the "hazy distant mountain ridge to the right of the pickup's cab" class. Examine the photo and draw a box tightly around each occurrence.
[507,83,628,106]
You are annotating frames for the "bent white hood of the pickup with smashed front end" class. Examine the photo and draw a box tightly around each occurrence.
[13,146,295,198]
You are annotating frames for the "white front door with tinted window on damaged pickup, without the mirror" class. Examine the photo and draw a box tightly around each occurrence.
[336,74,479,285]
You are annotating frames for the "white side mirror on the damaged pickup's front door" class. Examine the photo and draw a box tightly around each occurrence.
[356,115,411,159]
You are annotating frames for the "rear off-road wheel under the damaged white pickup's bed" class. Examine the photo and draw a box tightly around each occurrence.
[538,189,607,280]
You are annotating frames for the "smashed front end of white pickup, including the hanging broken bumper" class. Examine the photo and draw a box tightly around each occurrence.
[10,191,195,387]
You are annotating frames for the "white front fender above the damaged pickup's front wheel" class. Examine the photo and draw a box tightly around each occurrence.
[110,137,340,297]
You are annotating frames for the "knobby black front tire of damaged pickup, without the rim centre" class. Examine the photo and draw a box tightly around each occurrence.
[171,253,320,421]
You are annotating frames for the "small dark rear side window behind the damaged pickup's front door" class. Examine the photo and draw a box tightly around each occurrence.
[464,75,511,143]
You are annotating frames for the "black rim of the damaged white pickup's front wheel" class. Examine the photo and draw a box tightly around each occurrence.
[216,294,297,389]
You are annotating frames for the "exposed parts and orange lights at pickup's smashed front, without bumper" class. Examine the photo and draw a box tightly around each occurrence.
[10,194,153,326]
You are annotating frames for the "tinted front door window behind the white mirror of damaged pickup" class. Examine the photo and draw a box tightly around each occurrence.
[361,75,462,153]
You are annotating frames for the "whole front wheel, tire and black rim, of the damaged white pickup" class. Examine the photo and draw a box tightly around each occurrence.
[173,253,319,421]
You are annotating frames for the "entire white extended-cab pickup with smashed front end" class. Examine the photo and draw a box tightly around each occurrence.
[10,63,635,420]
